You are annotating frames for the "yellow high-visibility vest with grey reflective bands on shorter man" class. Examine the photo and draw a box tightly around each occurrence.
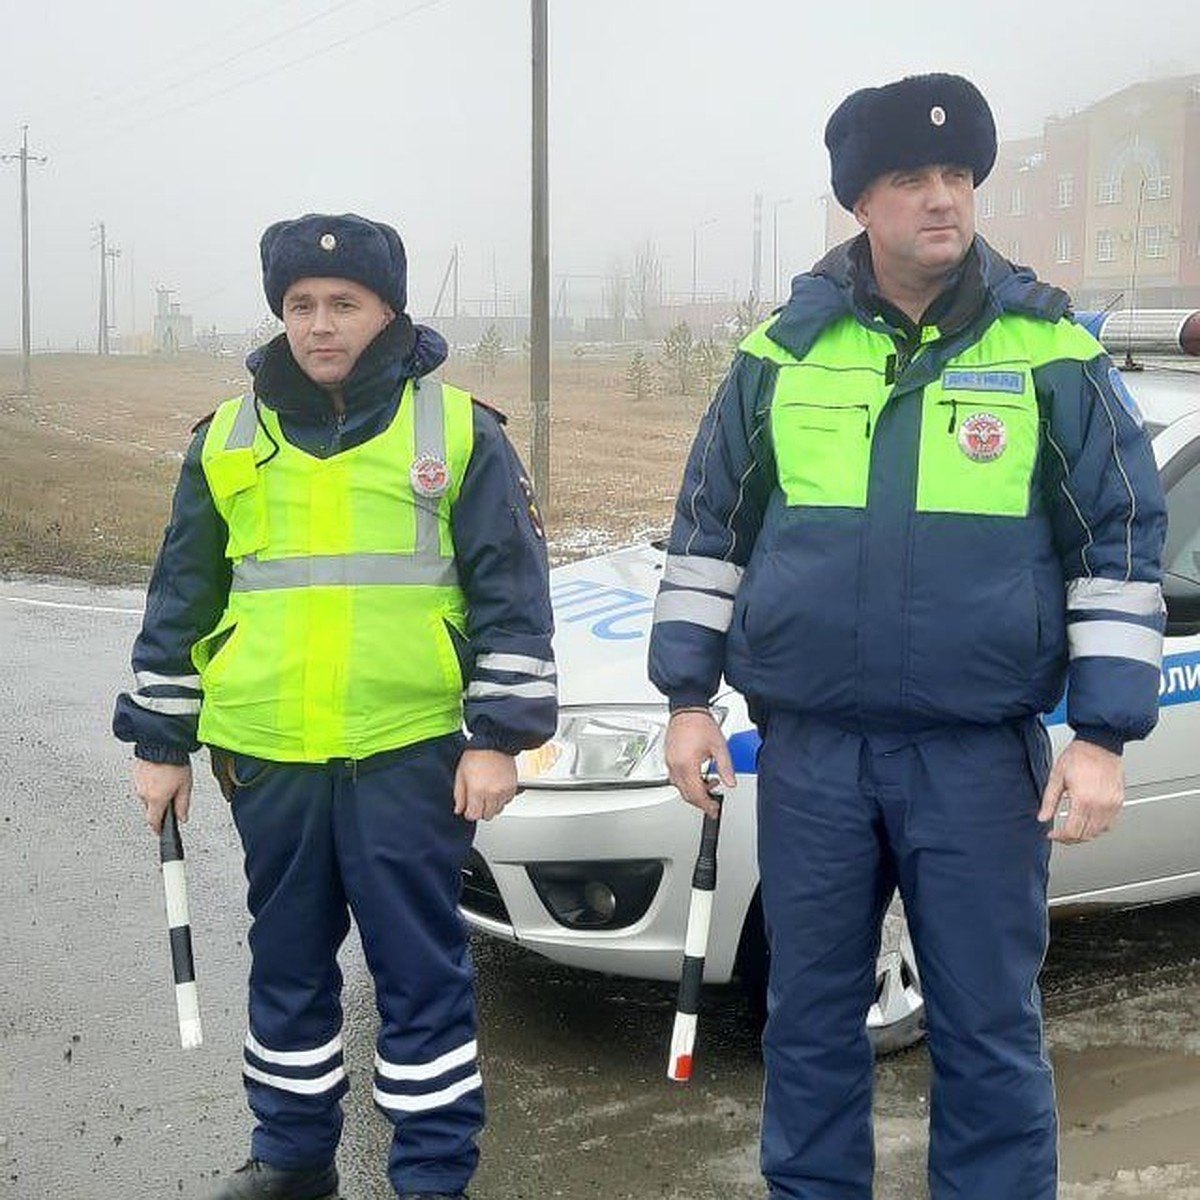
[192,380,473,762]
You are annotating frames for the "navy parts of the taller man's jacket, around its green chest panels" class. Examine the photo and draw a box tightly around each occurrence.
[649,236,1166,751]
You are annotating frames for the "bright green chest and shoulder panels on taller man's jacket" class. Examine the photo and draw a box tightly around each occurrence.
[740,316,1099,517]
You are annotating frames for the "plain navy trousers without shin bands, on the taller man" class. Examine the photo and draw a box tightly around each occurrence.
[758,712,1057,1200]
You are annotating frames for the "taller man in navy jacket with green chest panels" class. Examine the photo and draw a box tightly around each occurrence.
[650,74,1165,1200]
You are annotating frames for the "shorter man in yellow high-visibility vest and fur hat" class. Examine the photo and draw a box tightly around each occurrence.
[114,215,556,1200]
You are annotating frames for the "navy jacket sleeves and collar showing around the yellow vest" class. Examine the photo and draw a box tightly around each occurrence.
[113,316,557,762]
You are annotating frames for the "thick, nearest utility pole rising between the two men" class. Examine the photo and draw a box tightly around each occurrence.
[529,0,550,508]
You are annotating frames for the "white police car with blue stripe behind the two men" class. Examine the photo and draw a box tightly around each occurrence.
[462,314,1200,1050]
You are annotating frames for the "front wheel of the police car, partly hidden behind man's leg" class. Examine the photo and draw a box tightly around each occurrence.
[737,892,925,1055]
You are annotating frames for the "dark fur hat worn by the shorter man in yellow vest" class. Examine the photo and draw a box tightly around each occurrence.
[259,212,408,317]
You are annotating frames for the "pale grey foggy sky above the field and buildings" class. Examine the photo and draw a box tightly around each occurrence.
[0,0,1200,349]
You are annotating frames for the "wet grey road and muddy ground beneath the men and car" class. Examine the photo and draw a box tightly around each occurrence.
[0,580,1200,1200]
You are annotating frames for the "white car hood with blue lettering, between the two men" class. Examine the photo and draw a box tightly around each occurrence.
[550,545,666,704]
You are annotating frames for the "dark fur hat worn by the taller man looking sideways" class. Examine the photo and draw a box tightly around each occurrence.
[826,74,996,209]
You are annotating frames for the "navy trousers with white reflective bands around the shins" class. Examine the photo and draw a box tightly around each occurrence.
[225,734,484,1195]
